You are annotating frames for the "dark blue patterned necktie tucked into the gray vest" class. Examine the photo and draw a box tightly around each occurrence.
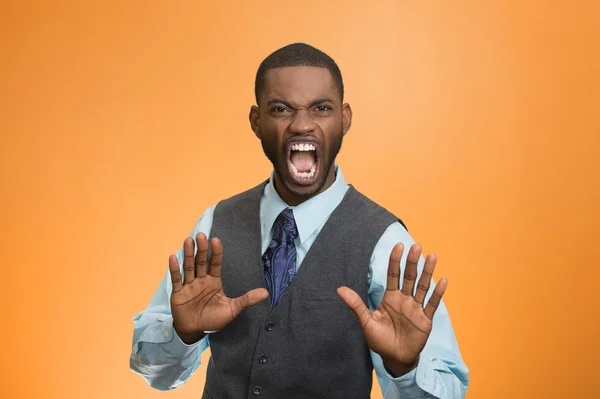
[262,208,298,308]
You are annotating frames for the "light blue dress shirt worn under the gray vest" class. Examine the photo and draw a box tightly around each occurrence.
[130,165,469,399]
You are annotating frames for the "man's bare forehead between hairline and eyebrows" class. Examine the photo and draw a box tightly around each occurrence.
[263,66,339,104]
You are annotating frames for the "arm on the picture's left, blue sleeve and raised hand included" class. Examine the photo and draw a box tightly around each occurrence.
[131,206,269,390]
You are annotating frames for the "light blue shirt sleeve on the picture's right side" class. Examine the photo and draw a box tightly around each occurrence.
[368,222,469,399]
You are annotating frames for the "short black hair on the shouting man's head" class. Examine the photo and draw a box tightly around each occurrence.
[254,43,344,104]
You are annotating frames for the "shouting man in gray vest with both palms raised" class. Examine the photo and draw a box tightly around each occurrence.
[131,43,469,399]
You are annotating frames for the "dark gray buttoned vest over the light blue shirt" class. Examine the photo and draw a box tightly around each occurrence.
[202,183,406,399]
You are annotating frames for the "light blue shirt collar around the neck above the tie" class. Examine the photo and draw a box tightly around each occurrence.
[261,164,349,243]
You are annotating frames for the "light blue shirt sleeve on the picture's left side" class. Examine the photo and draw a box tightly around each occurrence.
[129,206,216,391]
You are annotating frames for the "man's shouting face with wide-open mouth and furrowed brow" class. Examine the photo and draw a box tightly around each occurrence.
[250,66,352,205]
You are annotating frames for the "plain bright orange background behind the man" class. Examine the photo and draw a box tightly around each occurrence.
[0,0,600,399]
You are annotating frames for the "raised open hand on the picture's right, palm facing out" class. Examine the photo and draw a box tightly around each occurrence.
[337,244,448,376]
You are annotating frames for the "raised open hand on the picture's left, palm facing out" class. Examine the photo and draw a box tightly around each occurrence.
[169,233,269,345]
